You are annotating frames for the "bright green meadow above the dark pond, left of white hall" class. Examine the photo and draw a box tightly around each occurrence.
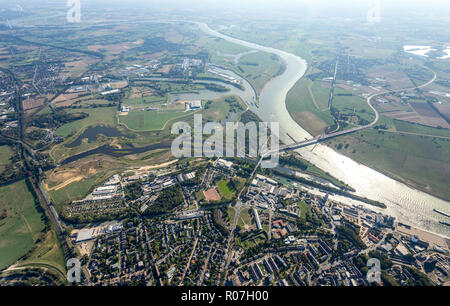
[56,107,117,137]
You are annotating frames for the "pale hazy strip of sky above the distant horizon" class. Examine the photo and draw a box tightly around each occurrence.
[0,0,450,18]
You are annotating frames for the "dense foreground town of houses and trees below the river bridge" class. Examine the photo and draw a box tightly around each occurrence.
[55,159,450,286]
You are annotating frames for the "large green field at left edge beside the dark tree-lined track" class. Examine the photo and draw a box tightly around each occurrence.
[0,181,44,269]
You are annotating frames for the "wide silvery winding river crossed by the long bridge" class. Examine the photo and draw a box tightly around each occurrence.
[197,23,450,237]
